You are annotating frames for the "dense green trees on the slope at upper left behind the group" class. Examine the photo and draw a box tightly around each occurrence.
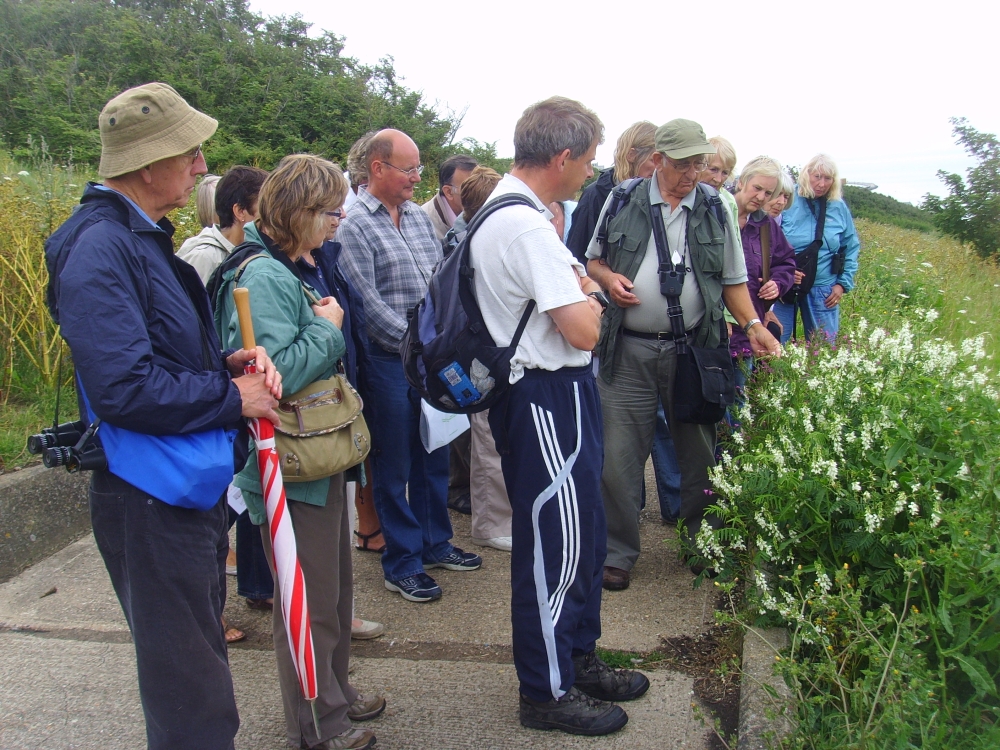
[0,0,501,187]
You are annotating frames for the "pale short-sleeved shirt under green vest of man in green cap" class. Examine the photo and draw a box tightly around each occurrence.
[587,172,747,333]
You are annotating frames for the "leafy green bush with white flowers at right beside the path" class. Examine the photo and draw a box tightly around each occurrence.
[697,309,1000,747]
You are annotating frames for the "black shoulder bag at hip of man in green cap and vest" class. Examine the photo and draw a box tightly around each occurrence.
[674,339,736,424]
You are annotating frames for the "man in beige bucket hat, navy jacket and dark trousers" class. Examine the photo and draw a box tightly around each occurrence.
[45,83,281,750]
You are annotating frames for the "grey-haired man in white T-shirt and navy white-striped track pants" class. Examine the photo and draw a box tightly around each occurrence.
[469,97,649,735]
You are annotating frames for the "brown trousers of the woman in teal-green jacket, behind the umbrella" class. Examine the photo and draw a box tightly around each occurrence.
[260,474,358,747]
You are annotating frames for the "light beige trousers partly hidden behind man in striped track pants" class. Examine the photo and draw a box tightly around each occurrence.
[469,410,511,539]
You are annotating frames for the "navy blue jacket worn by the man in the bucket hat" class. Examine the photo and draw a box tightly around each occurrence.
[45,184,246,440]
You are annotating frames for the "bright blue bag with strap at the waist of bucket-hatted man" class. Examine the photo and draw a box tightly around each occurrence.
[77,378,237,510]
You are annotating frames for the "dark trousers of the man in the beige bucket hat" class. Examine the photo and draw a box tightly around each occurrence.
[90,471,240,750]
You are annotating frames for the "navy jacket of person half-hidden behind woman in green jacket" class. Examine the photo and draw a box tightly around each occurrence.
[295,240,376,397]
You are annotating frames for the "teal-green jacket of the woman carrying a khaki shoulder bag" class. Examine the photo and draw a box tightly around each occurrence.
[215,224,345,525]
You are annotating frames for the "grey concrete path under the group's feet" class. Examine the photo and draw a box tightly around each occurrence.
[0,496,712,750]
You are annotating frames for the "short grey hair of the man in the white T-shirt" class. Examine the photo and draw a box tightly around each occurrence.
[514,96,604,167]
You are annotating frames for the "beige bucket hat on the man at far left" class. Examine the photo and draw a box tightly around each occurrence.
[97,83,219,177]
